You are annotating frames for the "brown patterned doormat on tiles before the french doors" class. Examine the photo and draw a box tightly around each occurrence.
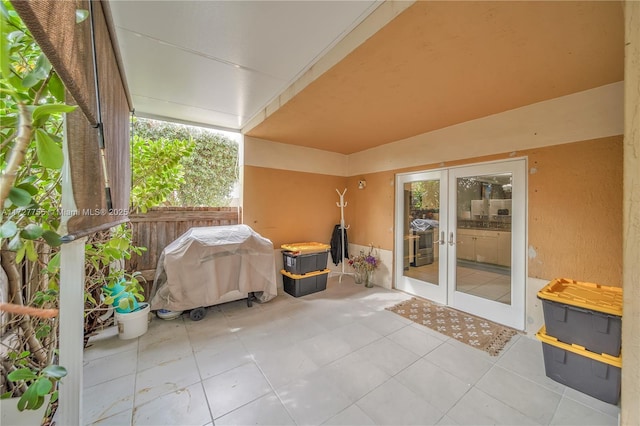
[387,297,518,356]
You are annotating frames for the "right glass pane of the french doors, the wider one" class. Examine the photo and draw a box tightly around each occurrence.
[454,173,512,304]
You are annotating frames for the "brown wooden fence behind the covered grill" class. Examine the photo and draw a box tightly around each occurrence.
[126,207,241,291]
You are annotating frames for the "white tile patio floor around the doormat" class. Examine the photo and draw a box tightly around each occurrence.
[83,277,619,426]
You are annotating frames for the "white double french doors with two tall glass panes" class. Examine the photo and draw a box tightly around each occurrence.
[395,159,526,330]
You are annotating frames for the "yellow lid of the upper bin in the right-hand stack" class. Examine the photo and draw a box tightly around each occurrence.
[538,278,622,316]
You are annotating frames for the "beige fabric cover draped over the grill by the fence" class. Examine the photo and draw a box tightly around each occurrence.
[151,225,277,311]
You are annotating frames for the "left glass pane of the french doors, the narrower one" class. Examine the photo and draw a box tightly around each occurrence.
[403,179,440,285]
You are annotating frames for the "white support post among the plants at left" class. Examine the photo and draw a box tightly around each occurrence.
[57,238,87,425]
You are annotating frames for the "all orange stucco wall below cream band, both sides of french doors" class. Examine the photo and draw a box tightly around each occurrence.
[244,136,622,286]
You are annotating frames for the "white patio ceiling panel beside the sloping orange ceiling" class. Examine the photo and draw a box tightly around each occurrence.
[109,0,380,129]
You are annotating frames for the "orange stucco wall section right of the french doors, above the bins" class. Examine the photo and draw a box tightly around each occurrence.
[527,136,623,287]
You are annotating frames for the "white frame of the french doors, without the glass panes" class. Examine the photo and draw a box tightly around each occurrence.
[394,157,527,330]
